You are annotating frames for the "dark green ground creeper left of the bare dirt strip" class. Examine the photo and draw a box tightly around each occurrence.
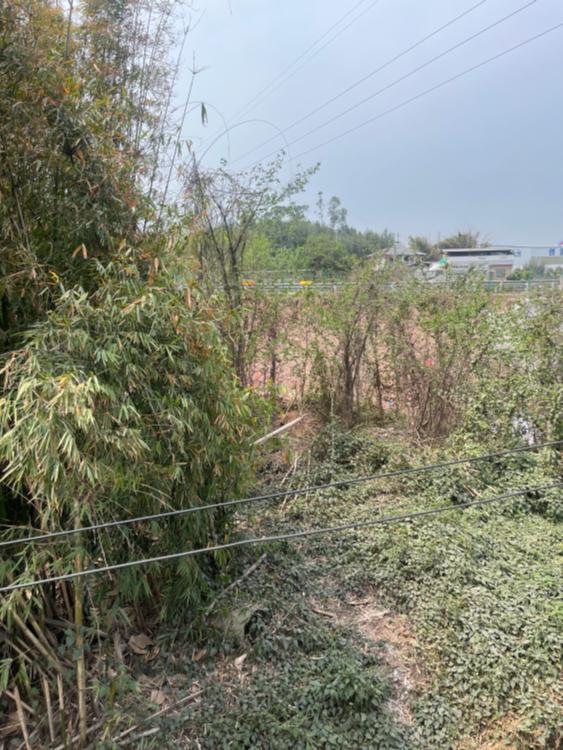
[159,551,409,750]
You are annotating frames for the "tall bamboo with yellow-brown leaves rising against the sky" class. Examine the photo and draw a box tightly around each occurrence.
[0,0,187,349]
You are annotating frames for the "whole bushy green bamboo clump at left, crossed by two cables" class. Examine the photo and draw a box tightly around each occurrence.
[0,265,260,744]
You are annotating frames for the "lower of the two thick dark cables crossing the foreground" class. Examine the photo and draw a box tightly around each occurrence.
[0,482,563,594]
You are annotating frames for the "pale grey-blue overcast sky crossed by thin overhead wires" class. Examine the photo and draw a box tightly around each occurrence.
[181,0,563,244]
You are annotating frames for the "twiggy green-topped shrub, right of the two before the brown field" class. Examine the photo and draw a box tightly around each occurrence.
[385,275,497,438]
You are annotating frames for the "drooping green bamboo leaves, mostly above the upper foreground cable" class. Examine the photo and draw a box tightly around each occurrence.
[0,266,251,601]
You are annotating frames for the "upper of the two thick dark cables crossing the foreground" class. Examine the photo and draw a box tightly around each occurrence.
[0,440,563,548]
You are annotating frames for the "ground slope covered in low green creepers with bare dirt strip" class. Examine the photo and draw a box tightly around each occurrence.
[99,427,563,750]
